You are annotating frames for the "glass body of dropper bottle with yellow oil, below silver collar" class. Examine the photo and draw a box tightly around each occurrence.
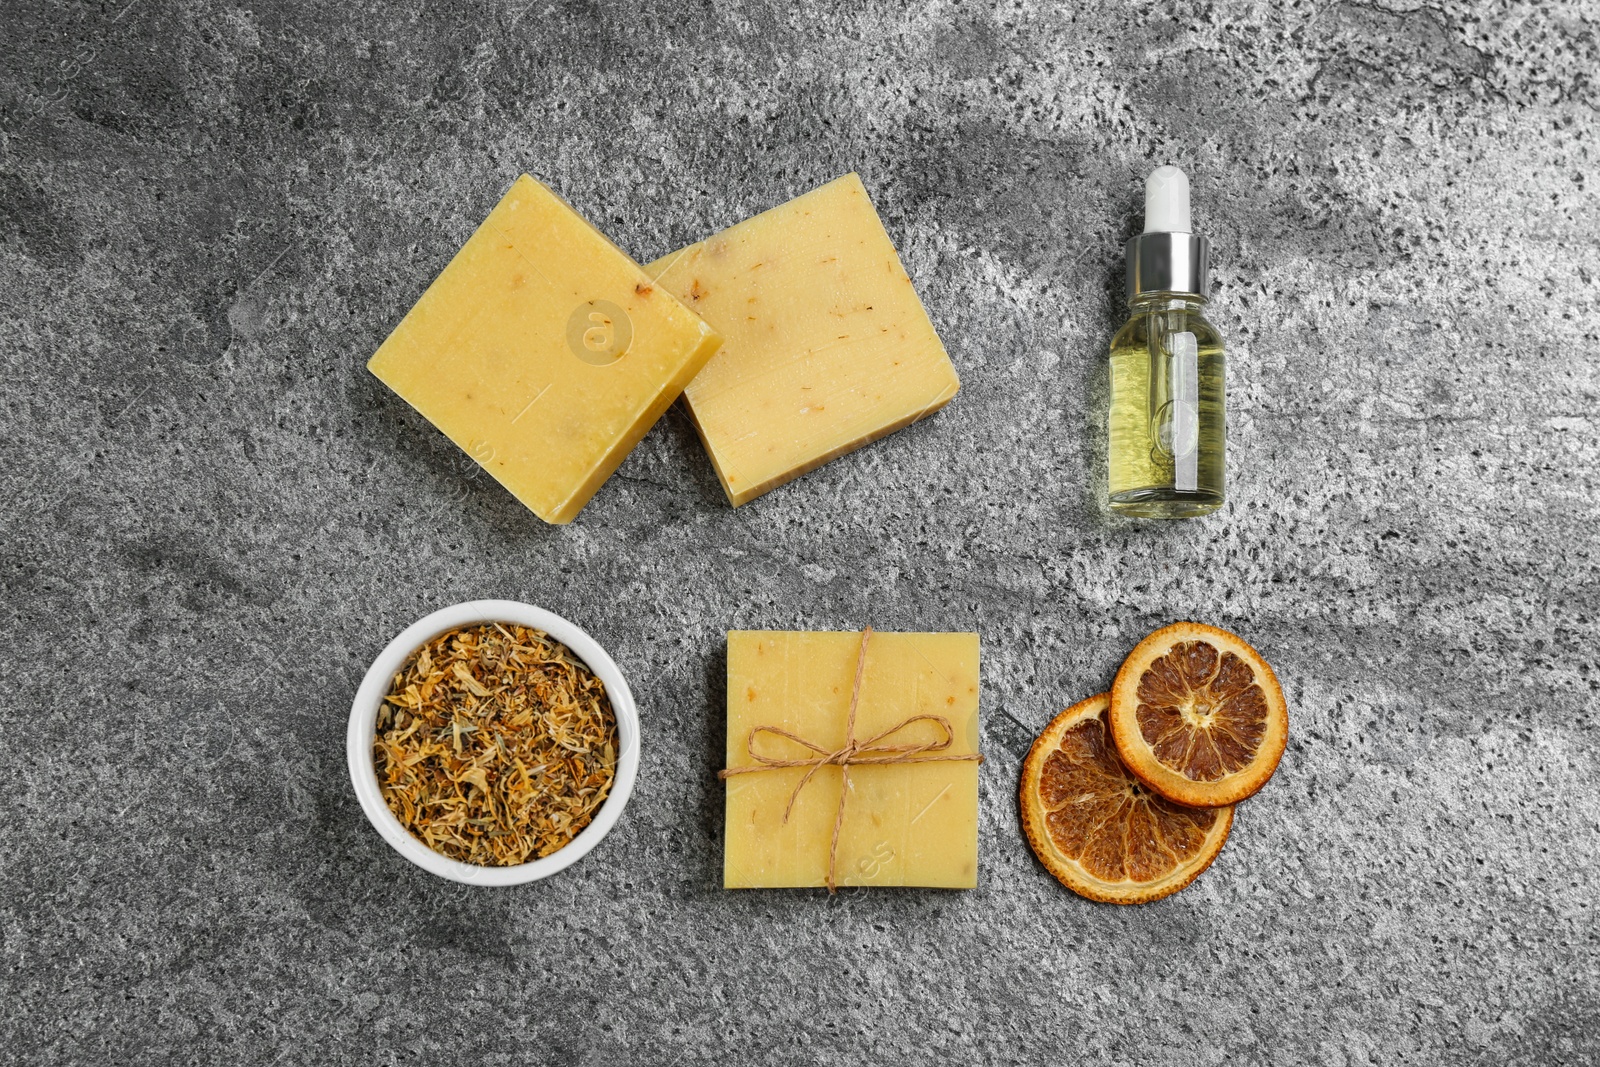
[1107,293,1227,518]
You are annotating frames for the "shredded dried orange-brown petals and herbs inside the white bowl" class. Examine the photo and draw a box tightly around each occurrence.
[373,622,616,867]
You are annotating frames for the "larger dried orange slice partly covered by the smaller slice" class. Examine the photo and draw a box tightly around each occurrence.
[1022,693,1234,904]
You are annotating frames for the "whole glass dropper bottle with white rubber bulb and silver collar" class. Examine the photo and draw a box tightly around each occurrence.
[1109,166,1226,518]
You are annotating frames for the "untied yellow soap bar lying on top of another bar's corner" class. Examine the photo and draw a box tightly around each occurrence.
[366,174,720,523]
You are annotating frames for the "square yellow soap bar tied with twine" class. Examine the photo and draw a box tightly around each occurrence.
[723,630,978,889]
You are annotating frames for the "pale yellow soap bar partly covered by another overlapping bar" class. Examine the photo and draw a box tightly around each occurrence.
[648,174,960,506]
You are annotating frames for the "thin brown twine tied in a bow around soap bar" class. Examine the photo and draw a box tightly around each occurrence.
[717,625,984,893]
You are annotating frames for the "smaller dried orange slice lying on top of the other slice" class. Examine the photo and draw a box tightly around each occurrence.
[1110,622,1290,808]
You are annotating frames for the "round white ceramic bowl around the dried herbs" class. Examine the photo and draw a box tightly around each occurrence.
[346,600,638,886]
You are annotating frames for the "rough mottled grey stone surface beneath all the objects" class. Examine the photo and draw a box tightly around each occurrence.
[0,0,1600,1065]
